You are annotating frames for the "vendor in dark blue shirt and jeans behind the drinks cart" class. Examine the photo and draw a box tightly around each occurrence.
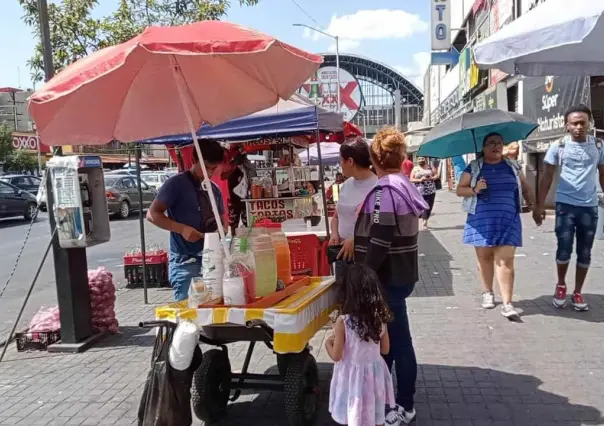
[147,140,224,301]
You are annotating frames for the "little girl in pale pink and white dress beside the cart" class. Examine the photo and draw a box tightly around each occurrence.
[325,265,398,426]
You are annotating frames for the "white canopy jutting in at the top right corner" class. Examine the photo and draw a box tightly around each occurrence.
[474,0,604,76]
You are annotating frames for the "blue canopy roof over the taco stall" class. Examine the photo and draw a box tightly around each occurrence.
[143,95,344,145]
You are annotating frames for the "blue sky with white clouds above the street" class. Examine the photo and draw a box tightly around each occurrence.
[0,0,430,88]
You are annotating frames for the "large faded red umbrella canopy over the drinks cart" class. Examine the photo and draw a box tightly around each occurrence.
[29,21,322,145]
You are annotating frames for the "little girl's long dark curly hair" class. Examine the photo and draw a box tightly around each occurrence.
[338,264,392,343]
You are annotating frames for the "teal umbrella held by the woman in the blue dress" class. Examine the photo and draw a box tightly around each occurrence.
[418,109,537,158]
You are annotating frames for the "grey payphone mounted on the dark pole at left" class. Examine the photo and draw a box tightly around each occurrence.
[46,155,111,248]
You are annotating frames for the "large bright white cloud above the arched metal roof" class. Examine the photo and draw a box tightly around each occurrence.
[326,9,428,40]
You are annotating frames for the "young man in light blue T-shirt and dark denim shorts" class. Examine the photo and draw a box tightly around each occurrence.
[533,105,604,311]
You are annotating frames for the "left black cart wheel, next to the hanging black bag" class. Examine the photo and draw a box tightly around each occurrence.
[191,349,231,423]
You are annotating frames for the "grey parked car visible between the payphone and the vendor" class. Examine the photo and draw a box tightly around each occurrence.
[105,174,157,219]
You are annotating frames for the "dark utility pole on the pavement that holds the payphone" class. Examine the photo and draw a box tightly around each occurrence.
[38,0,94,353]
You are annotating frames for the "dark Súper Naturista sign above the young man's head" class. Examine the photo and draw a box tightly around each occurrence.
[523,76,590,141]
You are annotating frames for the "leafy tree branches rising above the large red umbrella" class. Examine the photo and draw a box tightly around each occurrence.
[19,0,259,83]
